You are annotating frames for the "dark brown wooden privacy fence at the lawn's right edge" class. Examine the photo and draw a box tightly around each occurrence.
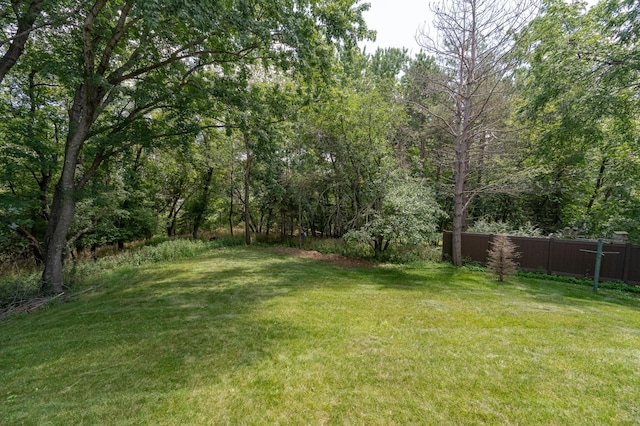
[442,232,640,285]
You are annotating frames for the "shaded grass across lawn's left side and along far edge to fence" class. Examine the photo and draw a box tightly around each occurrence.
[0,248,637,423]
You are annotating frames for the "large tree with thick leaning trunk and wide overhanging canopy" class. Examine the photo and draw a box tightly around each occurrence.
[35,0,366,292]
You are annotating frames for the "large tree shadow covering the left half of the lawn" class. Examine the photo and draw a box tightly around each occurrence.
[0,250,305,423]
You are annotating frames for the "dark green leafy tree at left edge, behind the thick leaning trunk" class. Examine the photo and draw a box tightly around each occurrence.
[0,58,66,263]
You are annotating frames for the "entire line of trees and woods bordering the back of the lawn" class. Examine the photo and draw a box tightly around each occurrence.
[0,0,640,291]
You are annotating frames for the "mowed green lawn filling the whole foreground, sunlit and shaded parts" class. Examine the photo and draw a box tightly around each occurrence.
[0,248,640,425]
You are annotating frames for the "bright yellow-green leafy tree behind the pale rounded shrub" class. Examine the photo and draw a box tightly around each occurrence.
[291,49,406,237]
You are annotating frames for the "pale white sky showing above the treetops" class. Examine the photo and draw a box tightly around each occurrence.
[361,0,597,55]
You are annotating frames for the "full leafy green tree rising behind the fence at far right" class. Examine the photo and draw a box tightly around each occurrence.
[518,0,640,238]
